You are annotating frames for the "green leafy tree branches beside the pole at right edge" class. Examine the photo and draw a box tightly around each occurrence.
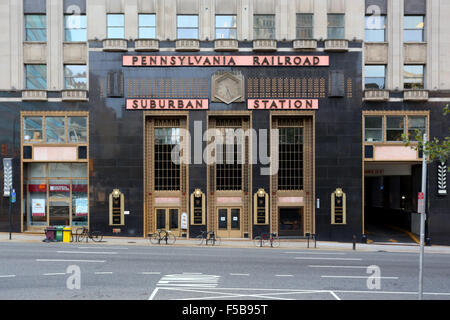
[402,105,450,171]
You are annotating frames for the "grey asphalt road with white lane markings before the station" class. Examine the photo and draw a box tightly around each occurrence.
[0,242,450,300]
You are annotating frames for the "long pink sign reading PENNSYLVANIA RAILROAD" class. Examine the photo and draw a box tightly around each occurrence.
[122,55,330,67]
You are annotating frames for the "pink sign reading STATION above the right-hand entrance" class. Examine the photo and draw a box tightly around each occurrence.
[247,99,319,110]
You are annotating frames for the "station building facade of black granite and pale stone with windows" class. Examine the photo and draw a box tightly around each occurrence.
[0,0,450,243]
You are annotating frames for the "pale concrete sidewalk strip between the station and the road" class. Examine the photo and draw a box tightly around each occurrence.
[0,232,450,254]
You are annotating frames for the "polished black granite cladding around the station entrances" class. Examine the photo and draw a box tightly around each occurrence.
[0,51,450,243]
